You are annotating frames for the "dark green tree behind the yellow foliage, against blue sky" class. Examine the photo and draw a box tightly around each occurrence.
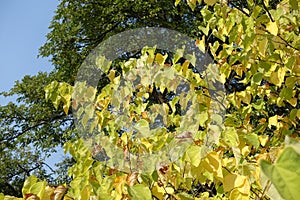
[0,0,211,195]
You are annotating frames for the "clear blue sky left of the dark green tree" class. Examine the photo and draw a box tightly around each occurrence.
[0,0,59,105]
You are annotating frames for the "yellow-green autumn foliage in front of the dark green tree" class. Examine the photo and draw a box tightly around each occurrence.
[0,0,300,199]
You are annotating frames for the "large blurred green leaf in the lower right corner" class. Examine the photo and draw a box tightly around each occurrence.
[260,147,300,200]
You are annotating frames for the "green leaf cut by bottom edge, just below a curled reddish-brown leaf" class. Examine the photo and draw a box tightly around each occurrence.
[128,184,152,200]
